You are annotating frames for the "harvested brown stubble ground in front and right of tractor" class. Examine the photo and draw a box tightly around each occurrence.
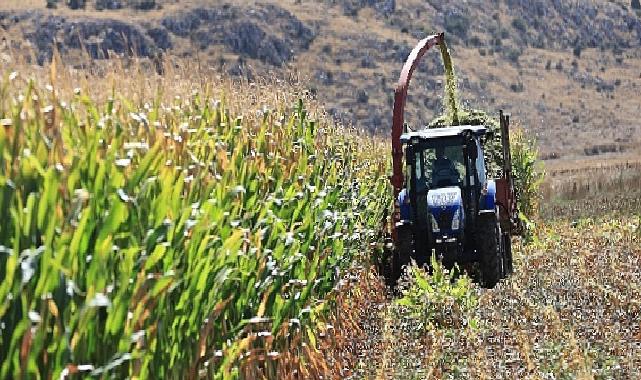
[332,217,641,379]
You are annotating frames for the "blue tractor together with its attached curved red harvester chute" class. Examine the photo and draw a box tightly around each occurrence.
[390,34,520,288]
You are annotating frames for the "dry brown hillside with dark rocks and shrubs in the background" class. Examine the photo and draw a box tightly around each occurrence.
[0,0,641,159]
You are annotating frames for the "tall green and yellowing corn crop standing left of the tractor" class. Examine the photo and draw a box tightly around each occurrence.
[0,73,390,379]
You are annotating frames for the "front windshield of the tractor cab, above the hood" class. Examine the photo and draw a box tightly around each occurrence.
[415,144,465,190]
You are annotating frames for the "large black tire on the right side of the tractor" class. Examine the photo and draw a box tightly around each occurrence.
[477,214,504,289]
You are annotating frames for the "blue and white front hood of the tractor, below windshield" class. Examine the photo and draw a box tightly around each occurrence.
[427,187,465,234]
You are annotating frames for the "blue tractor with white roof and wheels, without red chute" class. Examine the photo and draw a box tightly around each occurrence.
[393,122,513,287]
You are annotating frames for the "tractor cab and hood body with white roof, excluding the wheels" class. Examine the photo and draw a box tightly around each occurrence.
[398,126,494,262]
